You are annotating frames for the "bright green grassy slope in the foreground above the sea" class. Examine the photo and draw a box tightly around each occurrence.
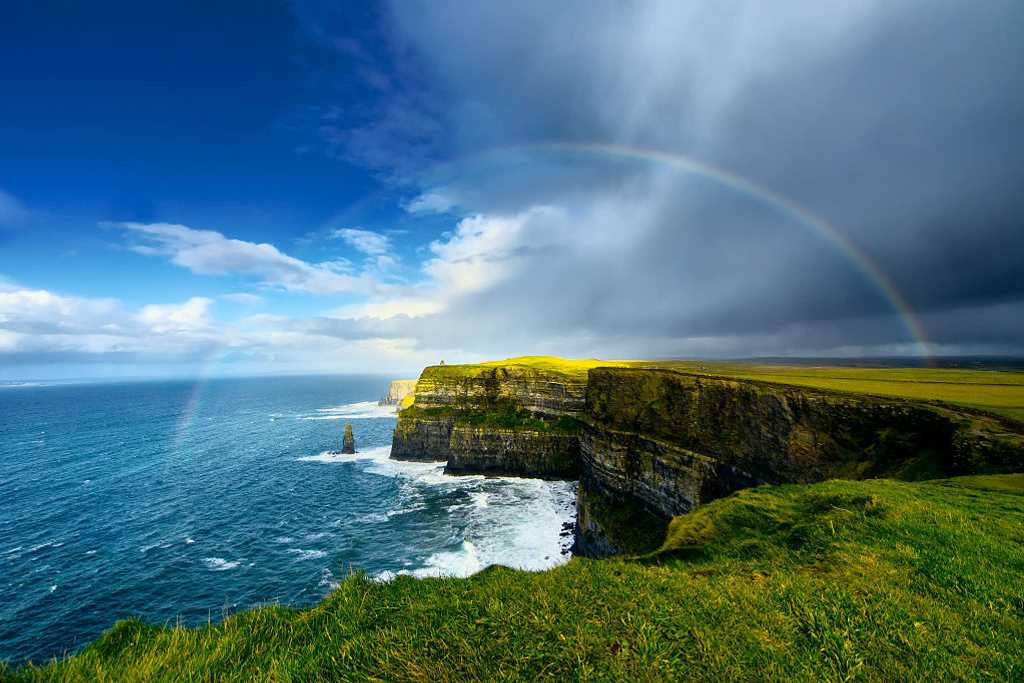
[6,475,1024,681]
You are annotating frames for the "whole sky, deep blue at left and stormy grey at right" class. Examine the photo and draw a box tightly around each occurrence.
[0,0,1024,380]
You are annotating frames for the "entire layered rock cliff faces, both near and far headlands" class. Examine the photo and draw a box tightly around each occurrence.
[391,362,1024,556]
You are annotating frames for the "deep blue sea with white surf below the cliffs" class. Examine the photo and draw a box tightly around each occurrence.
[0,377,573,661]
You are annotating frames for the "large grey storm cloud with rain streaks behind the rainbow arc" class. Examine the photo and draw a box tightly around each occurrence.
[315,0,1024,355]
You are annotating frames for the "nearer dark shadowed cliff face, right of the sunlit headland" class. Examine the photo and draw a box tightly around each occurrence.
[577,368,1024,555]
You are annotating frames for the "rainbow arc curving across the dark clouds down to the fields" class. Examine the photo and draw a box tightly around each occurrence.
[504,142,932,359]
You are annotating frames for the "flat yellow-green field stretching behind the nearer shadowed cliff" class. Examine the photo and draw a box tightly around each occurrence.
[637,360,1024,422]
